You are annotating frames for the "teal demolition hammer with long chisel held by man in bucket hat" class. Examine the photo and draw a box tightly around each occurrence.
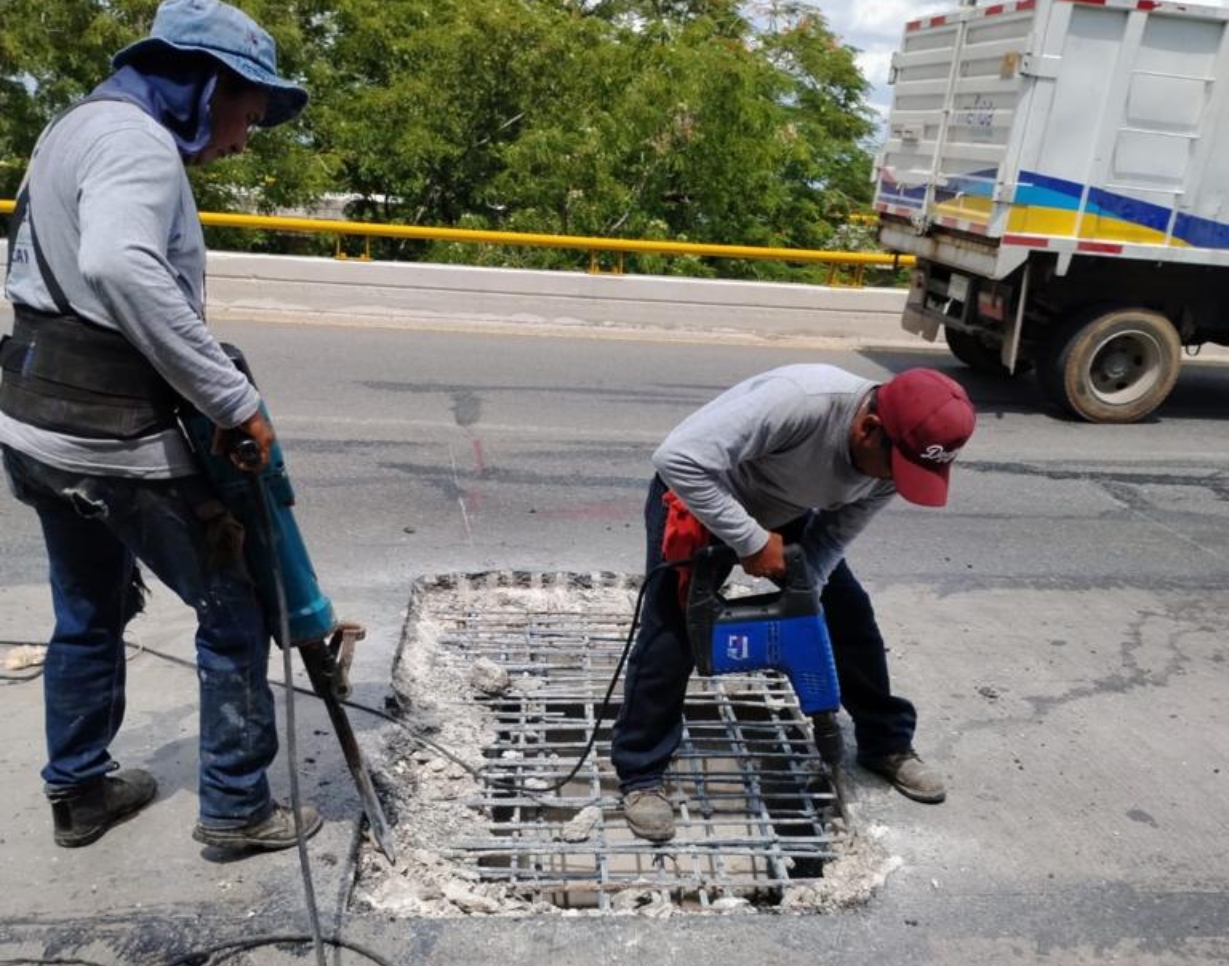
[179,343,396,862]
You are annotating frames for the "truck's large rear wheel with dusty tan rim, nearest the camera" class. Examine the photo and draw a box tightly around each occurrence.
[1037,308,1182,423]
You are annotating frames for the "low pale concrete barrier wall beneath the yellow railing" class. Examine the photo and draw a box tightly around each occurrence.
[0,245,922,347]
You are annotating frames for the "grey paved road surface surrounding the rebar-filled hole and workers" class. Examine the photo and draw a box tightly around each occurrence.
[0,324,1229,966]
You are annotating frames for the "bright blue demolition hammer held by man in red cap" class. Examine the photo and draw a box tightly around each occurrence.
[687,544,849,823]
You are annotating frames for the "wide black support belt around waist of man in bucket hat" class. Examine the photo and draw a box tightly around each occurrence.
[0,305,179,440]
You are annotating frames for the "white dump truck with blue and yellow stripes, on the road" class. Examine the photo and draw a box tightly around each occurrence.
[875,0,1229,423]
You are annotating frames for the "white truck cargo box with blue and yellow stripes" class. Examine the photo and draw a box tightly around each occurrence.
[875,0,1229,278]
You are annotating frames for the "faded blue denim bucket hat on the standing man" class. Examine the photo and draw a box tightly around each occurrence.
[111,0,307,128]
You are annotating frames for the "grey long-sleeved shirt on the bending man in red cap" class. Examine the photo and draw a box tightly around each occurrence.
[653,365,896,584]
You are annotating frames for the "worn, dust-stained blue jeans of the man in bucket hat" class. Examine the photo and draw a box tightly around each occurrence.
[4,447,278,828]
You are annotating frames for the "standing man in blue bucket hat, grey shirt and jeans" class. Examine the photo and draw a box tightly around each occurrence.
[0,0,321,849]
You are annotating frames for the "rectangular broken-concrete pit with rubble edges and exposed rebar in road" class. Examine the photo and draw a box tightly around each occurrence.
[354,573,898,917]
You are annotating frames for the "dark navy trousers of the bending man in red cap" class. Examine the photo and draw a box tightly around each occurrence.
[611,478,917,791]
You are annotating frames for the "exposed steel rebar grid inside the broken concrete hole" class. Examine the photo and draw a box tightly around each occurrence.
[412,575,836,911]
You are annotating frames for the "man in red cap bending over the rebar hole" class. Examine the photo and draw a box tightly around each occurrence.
[612,365,976,842]
